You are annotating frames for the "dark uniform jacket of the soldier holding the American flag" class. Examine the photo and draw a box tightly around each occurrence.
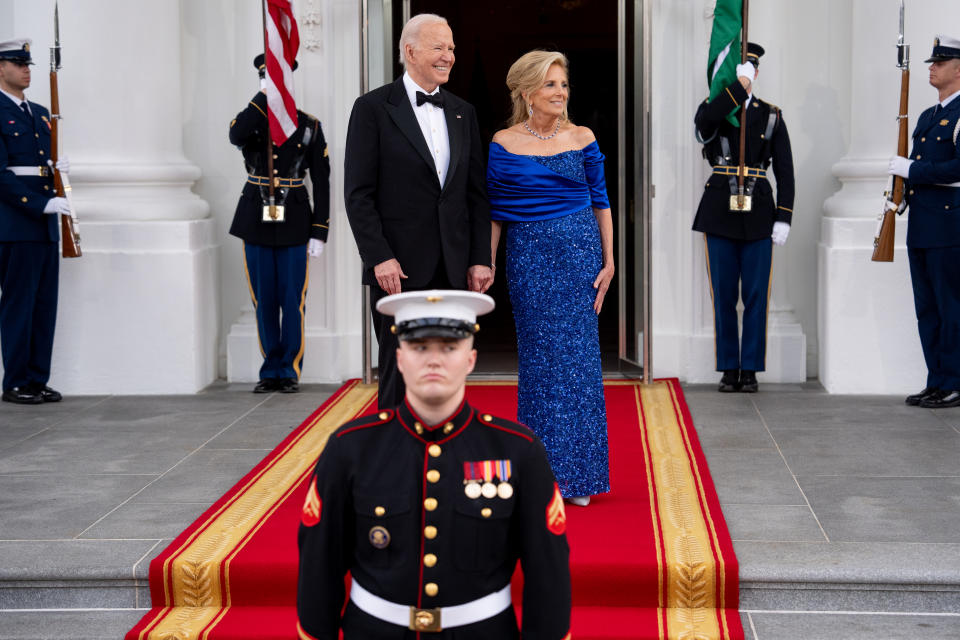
[230,92,330,246]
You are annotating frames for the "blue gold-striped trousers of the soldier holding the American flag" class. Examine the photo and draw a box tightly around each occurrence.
[243,243,309,380]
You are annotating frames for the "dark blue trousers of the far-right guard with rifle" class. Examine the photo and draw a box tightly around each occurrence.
[907,247,960,391]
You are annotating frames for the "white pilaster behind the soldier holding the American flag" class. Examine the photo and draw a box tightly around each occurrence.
[224,0,361,382]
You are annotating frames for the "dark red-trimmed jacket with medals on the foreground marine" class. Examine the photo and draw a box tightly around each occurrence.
[297,402,571,640]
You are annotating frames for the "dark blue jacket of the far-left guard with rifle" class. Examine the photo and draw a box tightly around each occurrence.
[0,93,60,242]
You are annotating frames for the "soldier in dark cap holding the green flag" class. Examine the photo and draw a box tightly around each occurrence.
[693,42,794,392]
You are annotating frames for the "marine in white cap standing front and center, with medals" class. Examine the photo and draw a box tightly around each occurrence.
[297,290,571,640]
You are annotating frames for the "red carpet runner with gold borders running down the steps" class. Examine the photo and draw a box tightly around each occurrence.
[126,380,743,640]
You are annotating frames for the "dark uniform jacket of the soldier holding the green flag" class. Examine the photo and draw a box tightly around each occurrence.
[693,80,794,240]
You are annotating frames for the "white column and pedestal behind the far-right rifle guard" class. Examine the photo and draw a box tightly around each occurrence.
[818,0,960,393]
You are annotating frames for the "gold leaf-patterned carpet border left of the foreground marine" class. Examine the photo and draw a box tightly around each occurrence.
[140,384,377,640]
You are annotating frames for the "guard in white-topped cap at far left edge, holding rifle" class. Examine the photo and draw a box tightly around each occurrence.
[0,40,70,404]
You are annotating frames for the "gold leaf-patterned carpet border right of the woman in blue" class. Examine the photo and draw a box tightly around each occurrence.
[640,382,721,640]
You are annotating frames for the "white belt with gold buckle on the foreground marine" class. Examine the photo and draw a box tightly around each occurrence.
[350,580,512,631]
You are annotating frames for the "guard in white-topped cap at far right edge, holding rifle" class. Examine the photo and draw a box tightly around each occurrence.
[890,36,960,409]
